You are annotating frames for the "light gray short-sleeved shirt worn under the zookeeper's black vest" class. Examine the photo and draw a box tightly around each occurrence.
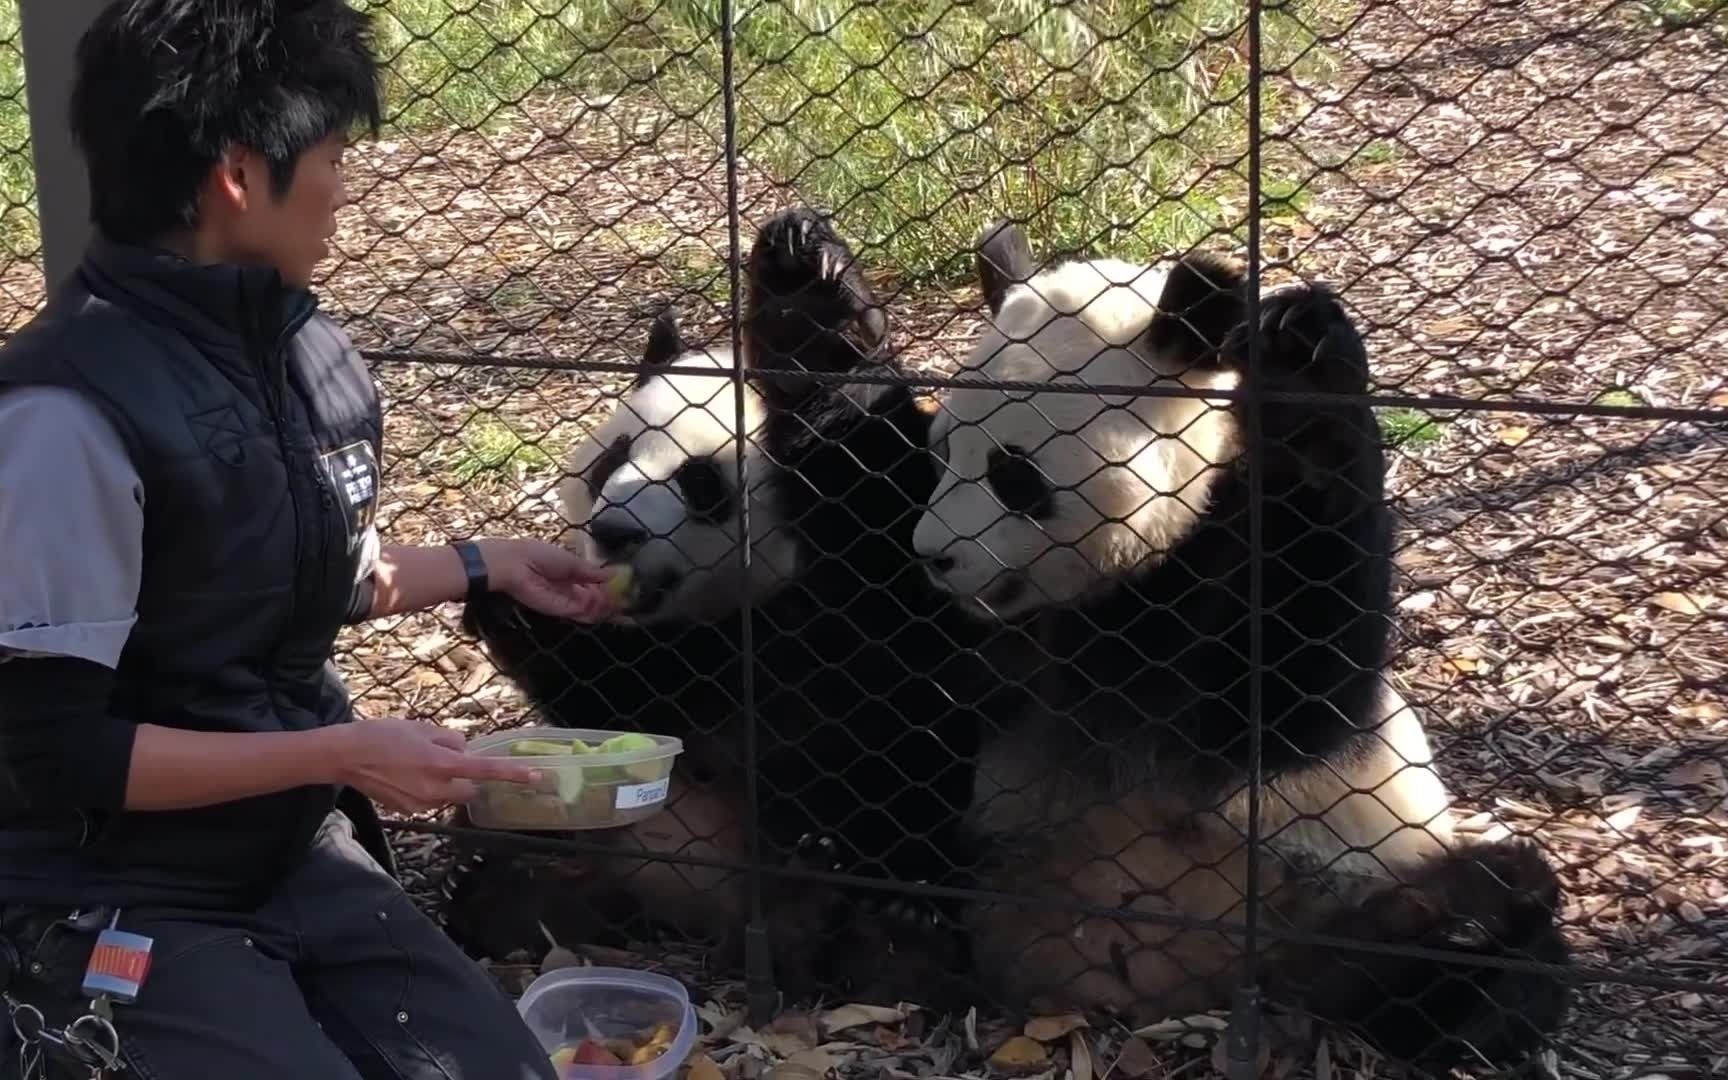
[0,378,378,669]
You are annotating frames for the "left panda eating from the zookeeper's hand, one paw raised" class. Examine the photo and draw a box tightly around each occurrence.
[444,207,976,992]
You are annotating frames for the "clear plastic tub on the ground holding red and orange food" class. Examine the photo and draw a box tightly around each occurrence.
[517,968,696,1080]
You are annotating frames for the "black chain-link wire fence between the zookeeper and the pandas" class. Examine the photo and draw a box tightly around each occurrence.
[0,0,1728,1078]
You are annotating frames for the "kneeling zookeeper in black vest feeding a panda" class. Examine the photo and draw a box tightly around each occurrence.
[0,0,608,1080]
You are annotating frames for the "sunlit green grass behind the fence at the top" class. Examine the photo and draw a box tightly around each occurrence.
[0,0,1332,280]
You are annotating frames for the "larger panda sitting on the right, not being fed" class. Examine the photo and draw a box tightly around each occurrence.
[914,223,1567,1068]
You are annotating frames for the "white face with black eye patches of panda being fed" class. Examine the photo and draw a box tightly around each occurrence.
[558,351,795,622]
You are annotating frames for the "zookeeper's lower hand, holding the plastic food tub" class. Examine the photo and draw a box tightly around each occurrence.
[323,717,539,814]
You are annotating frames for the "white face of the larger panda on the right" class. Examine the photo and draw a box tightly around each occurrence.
[914,259,1236,619]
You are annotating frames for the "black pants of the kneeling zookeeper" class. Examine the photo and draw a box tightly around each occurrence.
[0,814,555,1080]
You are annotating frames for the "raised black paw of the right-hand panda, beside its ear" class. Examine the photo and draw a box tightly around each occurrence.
[1230,285,1369,394]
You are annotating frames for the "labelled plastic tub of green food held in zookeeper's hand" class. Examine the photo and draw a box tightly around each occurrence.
[468,727,684,831]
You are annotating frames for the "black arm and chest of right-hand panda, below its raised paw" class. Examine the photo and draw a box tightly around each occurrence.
[1045,415,1389,790]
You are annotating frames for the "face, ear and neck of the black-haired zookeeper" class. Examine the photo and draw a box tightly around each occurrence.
[206,133,347,287]
